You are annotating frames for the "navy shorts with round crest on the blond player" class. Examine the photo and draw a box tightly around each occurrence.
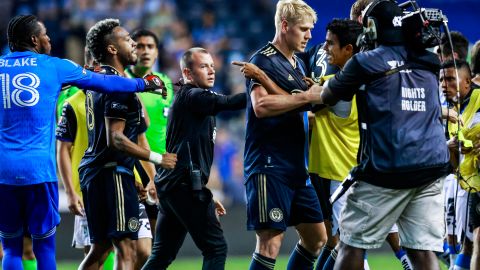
[245,174,323,231]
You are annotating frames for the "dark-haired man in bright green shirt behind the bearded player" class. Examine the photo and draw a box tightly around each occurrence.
[125,29,173,233]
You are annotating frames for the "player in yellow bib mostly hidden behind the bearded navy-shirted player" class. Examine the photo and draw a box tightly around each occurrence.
[56,48,155,269]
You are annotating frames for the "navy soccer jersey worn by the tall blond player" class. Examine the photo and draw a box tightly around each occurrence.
[244,43,308,184]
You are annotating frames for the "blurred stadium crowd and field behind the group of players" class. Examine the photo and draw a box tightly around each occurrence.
[0,0,480,269]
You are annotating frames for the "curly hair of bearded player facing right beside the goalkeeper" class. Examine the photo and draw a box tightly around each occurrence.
[87,19,120,63]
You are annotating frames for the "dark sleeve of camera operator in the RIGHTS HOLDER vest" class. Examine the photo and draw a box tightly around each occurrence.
[328,56,368,101]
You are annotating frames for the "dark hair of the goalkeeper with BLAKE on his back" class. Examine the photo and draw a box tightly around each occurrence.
[7,15,41,52]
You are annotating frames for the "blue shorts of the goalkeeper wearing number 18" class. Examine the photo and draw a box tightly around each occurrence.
[0,182,60,239]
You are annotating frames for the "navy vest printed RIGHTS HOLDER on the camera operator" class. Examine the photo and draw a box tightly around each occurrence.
[352,46,449,175]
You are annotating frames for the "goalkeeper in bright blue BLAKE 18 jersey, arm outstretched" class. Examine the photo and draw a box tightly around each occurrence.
[0,15,162,270]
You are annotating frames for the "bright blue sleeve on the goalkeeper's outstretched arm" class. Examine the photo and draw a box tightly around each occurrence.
[53,58,145,93]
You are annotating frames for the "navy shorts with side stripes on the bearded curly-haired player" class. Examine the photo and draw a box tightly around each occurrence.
[82,167,140,243]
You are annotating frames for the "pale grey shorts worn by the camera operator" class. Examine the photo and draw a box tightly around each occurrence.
[340,177,445,252]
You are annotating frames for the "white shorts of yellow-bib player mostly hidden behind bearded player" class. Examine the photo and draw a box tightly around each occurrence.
[72,203,152,249]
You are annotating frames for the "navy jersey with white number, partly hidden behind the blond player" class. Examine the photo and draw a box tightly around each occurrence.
[297,43,340,82]
